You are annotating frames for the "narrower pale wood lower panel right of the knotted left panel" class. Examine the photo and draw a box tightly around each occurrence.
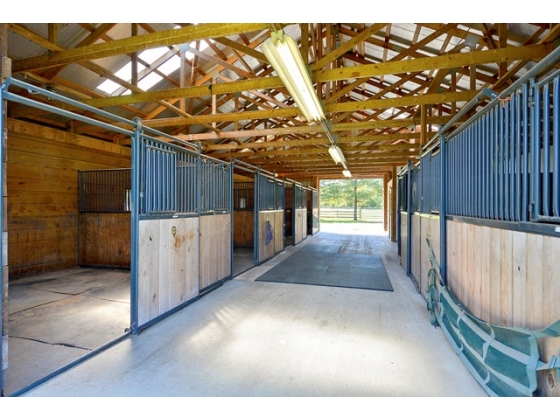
[199,213,231,290]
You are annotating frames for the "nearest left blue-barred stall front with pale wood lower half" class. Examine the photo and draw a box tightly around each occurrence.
[132,139,233,331]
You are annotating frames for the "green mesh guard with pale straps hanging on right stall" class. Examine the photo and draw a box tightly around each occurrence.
[426,238,560,397]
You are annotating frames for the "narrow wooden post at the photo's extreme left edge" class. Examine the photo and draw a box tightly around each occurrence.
[0,23,12,396]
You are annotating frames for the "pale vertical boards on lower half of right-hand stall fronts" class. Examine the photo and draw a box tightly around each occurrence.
[401,213,560,396]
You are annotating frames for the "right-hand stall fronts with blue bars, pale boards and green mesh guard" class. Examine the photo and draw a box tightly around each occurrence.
[398,53,560,397]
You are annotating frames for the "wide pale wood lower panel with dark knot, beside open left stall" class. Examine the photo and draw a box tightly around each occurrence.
[138,217,200,326]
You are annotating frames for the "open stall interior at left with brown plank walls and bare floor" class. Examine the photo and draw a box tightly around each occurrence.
[3,120,131,395]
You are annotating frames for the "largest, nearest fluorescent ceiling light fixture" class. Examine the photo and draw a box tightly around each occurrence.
[261,31,325,122]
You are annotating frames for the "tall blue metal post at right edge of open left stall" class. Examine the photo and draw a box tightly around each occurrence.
[130,118,142,334]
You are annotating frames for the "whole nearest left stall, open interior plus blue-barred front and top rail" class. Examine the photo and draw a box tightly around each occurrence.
[0,79,233,396]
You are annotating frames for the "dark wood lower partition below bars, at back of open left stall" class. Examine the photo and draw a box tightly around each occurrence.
[78,213,131,268]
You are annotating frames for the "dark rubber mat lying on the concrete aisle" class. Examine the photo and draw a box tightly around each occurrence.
[256,245,393,292]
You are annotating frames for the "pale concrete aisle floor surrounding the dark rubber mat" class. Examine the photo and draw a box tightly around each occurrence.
[19,224,486,397]
